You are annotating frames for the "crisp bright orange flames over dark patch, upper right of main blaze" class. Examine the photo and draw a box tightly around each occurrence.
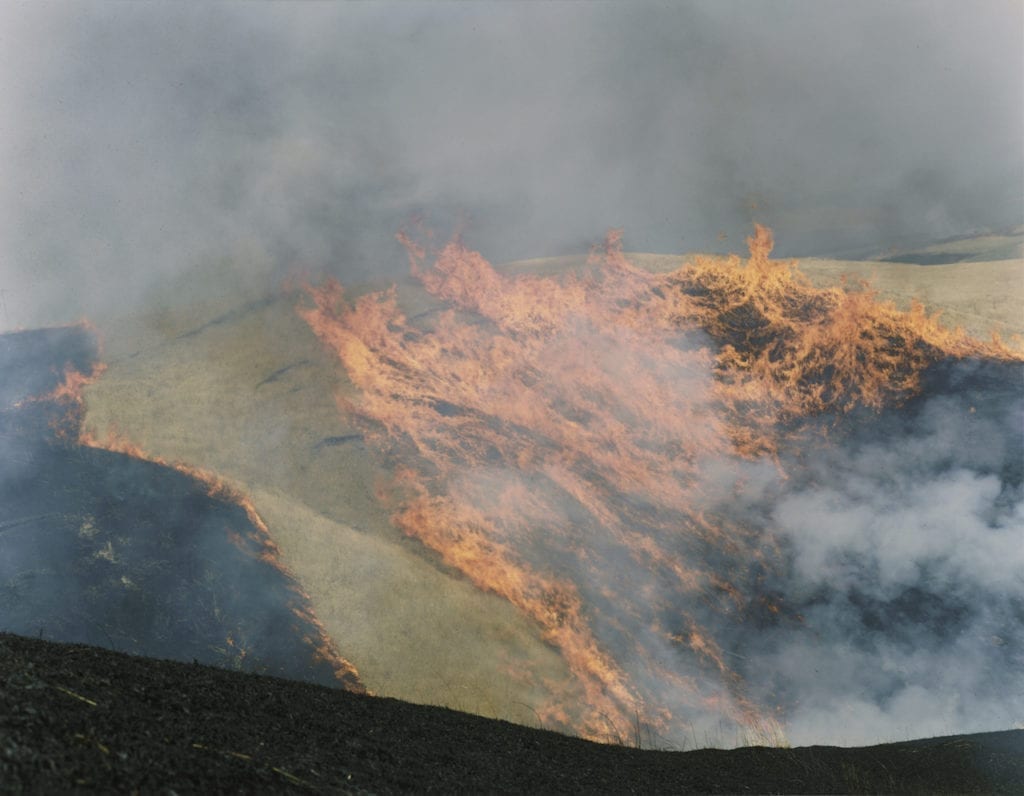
[667,224,1020,453]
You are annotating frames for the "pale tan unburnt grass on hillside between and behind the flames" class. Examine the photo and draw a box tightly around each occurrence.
[79,231,1024,737]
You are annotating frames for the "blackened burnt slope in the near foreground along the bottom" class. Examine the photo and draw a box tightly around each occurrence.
[0,634,1024,793]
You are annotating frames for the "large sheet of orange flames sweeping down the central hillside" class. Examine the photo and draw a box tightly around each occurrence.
[299,226,1013,740]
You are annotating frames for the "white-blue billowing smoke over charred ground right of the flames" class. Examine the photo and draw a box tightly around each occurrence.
[746,362,1024,744]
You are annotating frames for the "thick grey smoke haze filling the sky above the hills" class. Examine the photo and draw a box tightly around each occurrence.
[0,0,1024,328]
